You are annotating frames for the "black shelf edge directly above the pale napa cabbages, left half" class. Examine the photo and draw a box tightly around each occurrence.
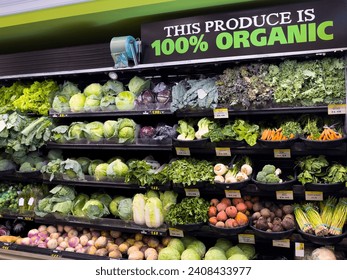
[43,179,171,191]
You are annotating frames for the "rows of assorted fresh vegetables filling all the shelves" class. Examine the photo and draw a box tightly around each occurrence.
[0,54,347,260]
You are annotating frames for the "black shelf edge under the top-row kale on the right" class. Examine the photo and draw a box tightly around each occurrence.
[175,106,328,118]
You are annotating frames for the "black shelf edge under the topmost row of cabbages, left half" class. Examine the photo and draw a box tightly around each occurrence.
[49,109,173,118]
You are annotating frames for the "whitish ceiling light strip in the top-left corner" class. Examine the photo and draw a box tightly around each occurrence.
[0,0,91,16]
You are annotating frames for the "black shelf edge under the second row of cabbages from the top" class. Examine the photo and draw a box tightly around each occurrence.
[46,142,172,151]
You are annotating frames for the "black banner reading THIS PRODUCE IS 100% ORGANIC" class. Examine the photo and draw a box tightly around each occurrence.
[141,0,347,63]
